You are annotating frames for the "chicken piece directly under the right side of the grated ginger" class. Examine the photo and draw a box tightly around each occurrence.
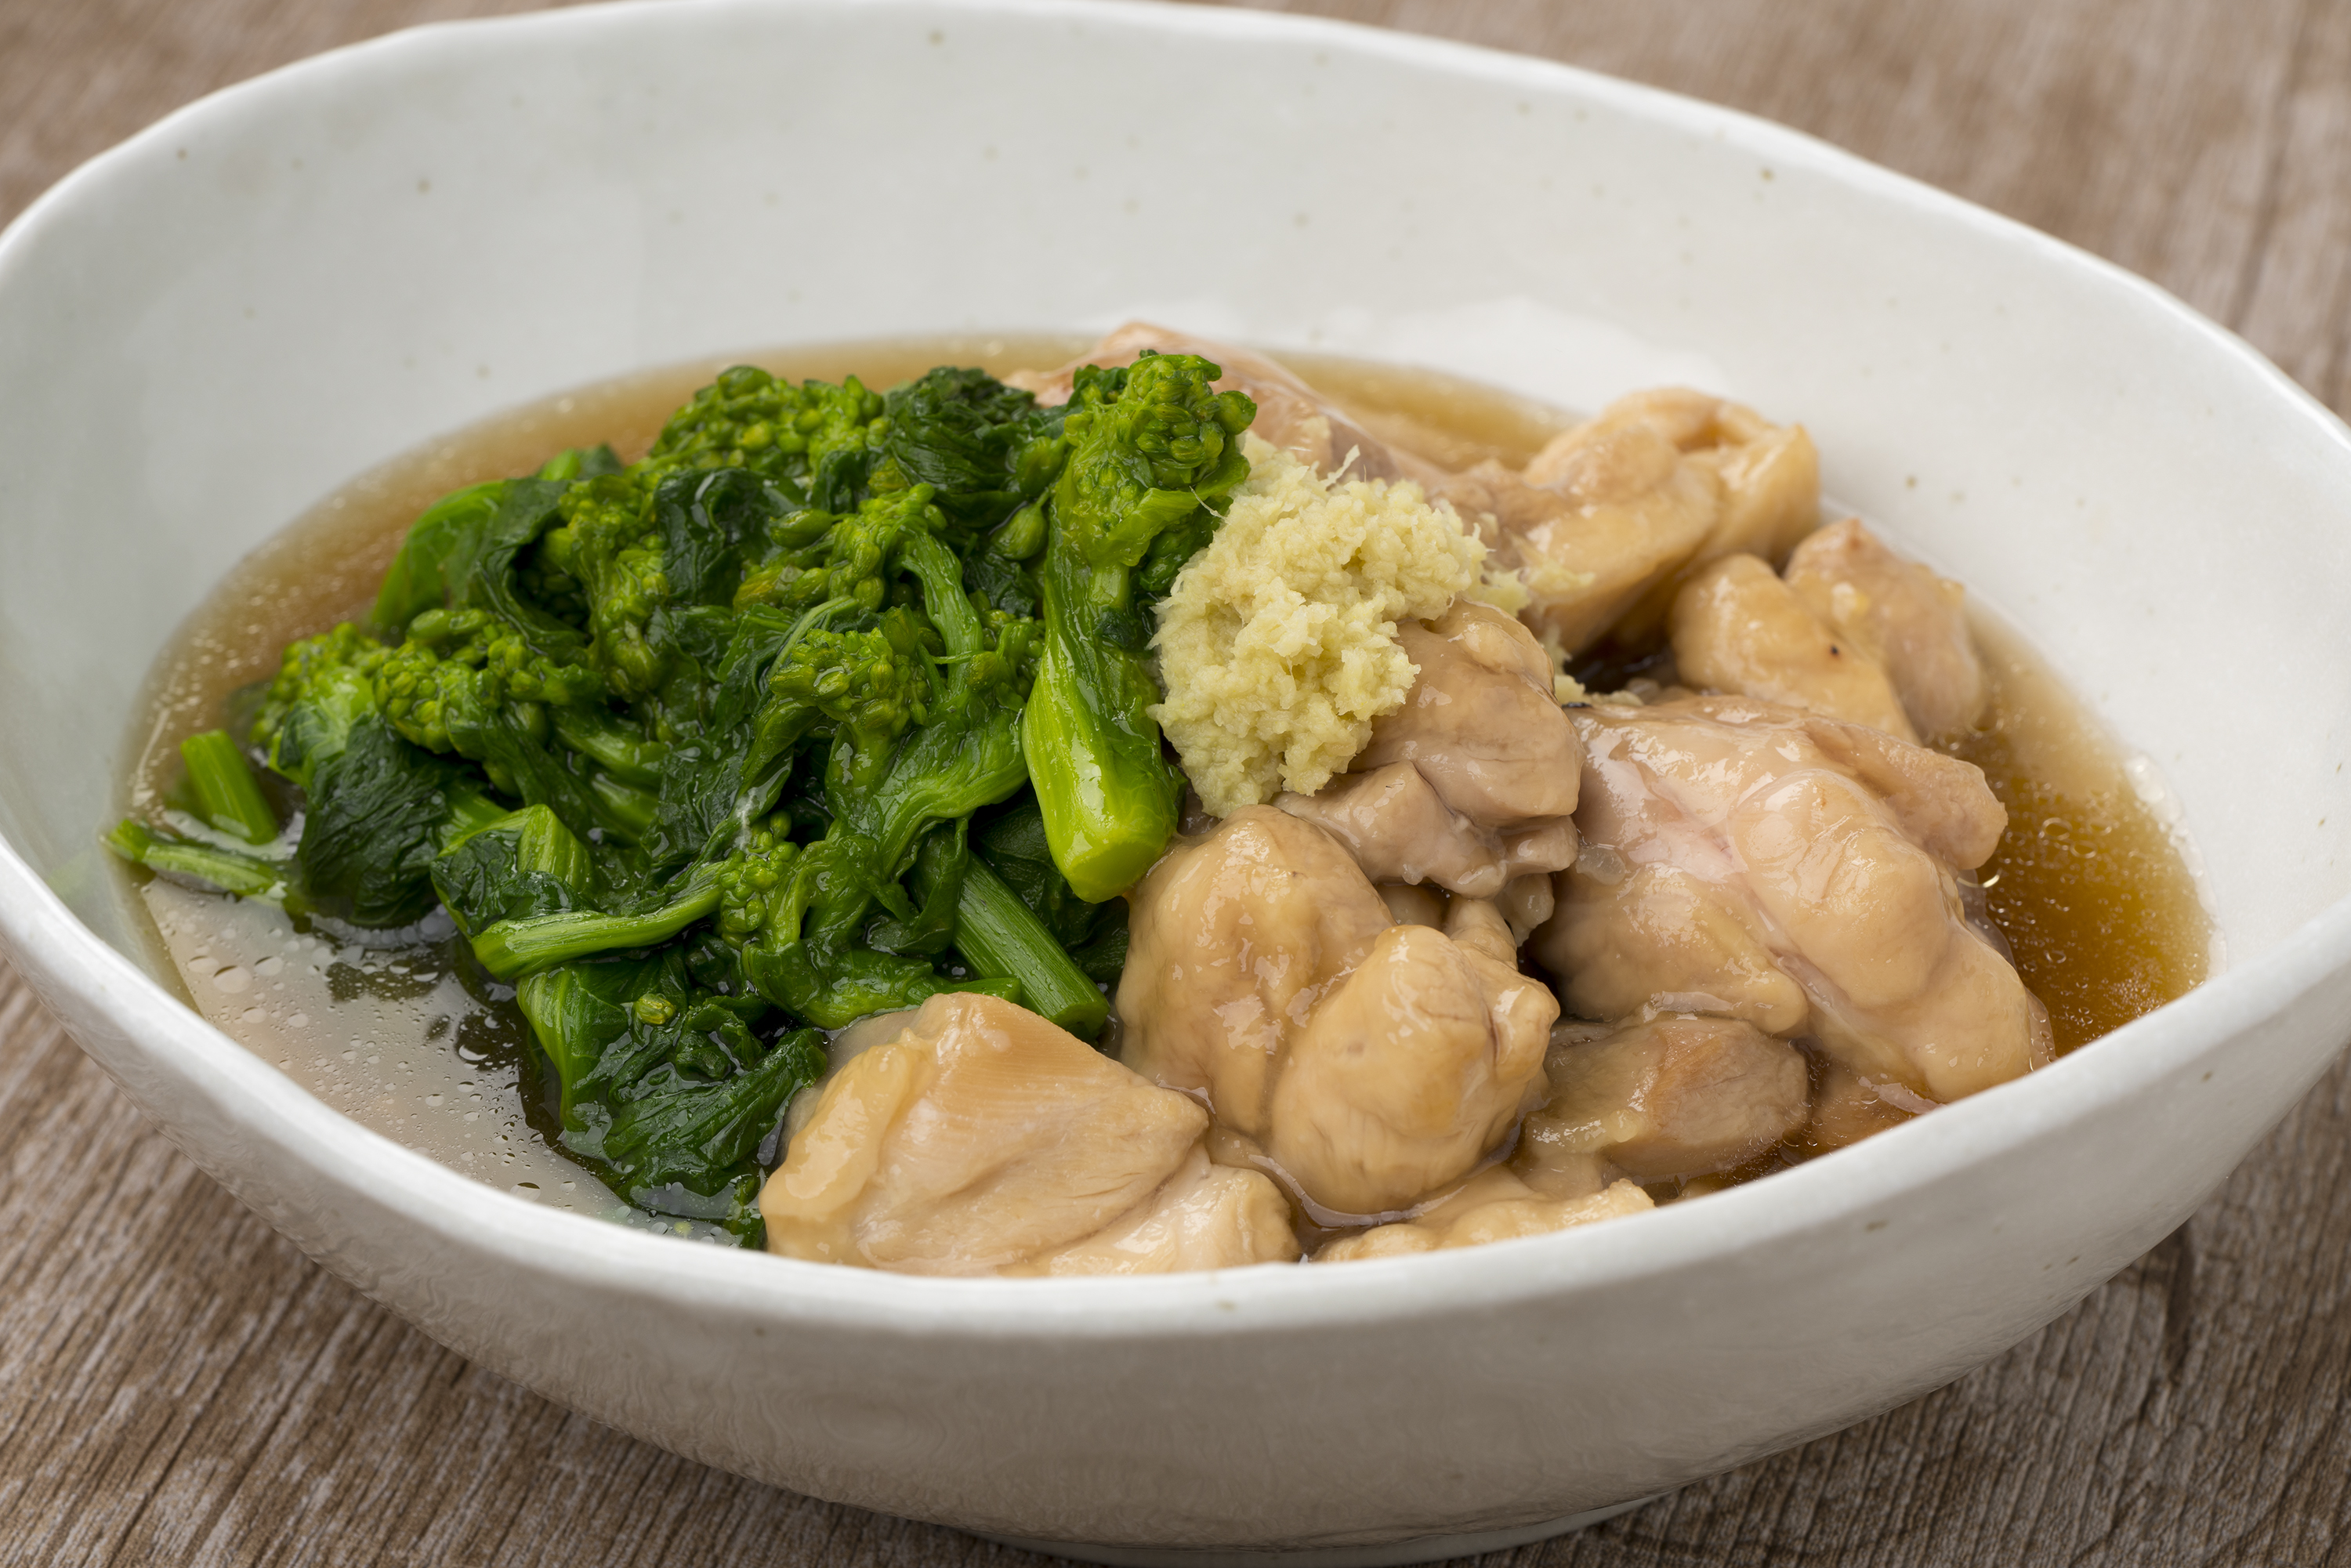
[1274,599,1582,898]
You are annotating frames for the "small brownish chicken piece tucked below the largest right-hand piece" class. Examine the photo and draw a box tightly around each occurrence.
[1519,1016,1810,1182]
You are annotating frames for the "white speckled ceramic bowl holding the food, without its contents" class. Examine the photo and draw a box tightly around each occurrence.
[0,0,2351,1559]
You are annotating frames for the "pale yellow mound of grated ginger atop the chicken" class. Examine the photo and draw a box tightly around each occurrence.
[1150,435,1486,816]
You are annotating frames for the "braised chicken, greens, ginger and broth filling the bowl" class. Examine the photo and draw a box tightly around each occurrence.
[108,324,2205,1274]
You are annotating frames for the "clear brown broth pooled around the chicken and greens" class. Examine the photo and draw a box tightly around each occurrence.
[125,336,2212,1234]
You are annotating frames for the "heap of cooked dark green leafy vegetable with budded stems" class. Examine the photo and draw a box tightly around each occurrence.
[106,355,1251,1241]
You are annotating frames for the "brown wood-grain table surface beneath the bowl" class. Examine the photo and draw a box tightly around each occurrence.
[0,0,2351,1568]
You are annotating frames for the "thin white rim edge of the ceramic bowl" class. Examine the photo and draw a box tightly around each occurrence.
[0,0,2351,1340]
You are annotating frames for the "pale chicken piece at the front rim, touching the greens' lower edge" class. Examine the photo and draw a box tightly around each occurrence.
[759,992,1298,1274]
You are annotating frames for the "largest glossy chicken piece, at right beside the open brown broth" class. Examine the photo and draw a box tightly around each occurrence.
[1533,698,2050,1100]
